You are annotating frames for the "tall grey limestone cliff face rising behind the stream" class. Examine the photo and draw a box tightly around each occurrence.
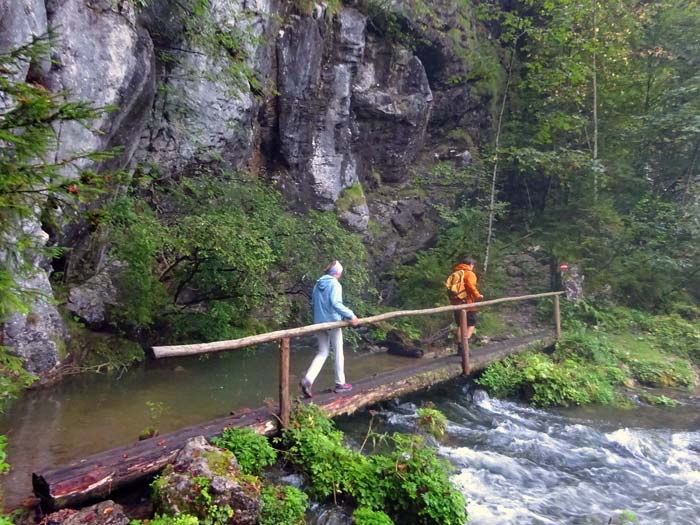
[0,0,488,372]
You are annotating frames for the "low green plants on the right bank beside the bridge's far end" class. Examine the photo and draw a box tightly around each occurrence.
[479,301,700,406]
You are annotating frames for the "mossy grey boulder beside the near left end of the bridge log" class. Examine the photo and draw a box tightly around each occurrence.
[154,436,260,525]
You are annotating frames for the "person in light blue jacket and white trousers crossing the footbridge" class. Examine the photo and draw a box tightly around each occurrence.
[301,261,359,397]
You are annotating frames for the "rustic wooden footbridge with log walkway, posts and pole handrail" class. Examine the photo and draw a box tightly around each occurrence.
[32,292,563,510]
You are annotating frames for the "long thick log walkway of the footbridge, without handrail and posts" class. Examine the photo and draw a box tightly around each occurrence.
[32,331,554,510]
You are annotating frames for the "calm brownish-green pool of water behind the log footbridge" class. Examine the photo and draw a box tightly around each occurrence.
[0,338,411,508]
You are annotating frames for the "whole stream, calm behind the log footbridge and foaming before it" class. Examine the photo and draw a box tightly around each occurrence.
[0,343,700,525]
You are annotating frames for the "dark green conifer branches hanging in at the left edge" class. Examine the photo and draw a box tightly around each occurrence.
[0,37,113,321]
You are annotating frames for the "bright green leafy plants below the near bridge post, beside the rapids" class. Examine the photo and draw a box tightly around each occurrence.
[282,405,467,525]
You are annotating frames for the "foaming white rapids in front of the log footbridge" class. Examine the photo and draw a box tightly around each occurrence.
[339,382,700,525]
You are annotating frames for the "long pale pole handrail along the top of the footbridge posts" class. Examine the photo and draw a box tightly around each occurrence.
[151,292,564,359]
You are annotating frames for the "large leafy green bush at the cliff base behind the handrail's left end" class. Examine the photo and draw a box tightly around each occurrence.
[103,170,373,341]
